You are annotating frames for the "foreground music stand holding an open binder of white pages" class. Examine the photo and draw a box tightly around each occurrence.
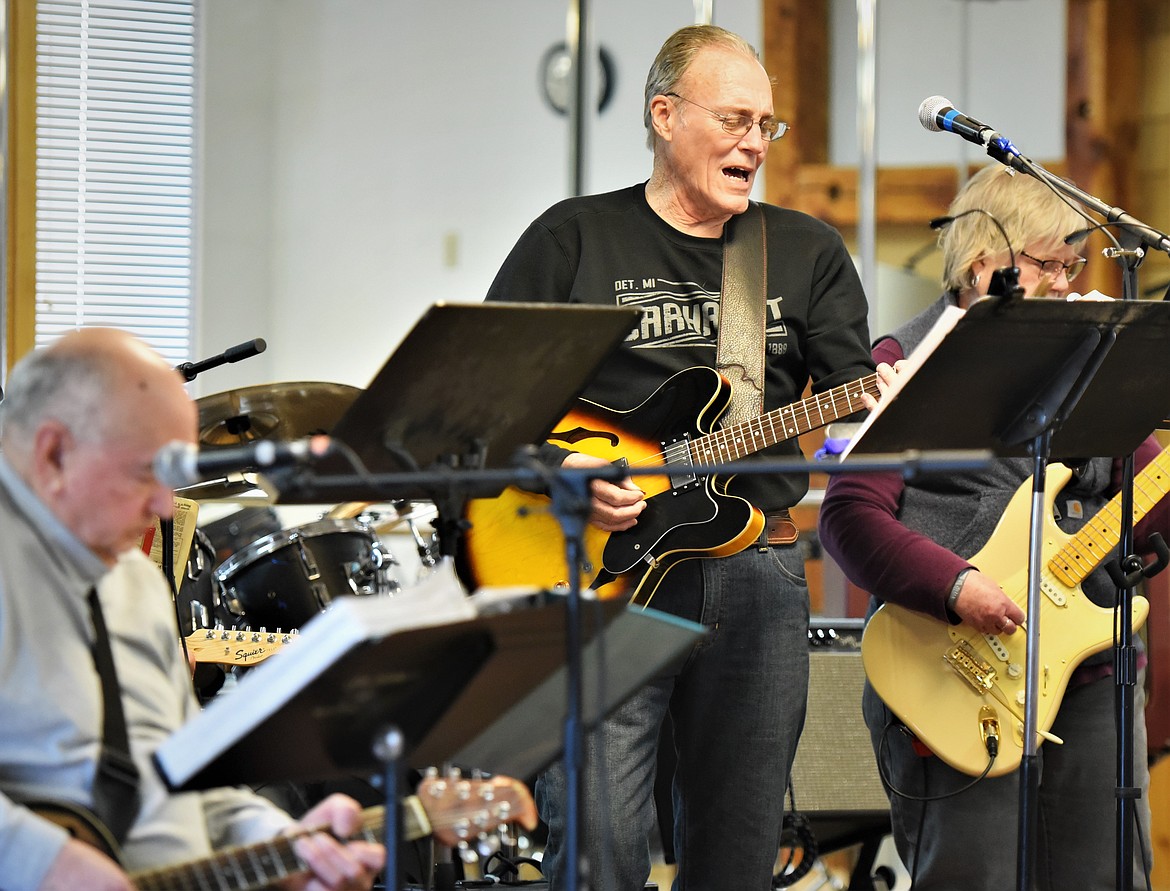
[154,576,703,887]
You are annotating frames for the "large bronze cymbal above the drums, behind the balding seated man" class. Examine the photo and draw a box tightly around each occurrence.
[195,381,362,446]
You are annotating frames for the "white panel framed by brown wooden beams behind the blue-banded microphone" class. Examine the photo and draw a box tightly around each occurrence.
[830,0,1065,167]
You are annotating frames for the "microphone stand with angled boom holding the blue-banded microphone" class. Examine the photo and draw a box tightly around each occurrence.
[987,143,1170,891]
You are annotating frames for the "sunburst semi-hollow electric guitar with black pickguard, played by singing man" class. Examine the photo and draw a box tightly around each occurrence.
[461,367,879,606]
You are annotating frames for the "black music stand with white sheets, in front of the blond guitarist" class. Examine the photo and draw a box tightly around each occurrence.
[848,297,1170,887]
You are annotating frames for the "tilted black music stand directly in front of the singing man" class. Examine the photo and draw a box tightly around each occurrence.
[267,303,639,500]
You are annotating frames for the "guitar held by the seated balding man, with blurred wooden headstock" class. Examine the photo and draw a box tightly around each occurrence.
[30,774,536,891]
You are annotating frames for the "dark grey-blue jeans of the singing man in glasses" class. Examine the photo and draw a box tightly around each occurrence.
[536,546,808,891]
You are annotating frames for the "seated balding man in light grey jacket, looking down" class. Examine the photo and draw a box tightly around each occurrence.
[0,329,385,891]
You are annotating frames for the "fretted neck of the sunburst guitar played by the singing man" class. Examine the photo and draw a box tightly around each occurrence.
[690,374,880,464]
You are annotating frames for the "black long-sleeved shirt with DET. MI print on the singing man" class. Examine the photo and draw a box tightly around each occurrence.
[488,184,873,510]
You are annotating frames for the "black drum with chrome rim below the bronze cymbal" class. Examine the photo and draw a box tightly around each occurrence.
[215,519,398,630]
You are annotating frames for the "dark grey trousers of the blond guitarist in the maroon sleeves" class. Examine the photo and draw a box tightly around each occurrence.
[862,671,1150,891]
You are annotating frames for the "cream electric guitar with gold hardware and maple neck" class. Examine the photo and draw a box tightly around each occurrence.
[861,450,1170,776]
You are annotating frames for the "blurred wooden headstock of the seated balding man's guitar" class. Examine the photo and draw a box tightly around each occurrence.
[415,772,536,847]
